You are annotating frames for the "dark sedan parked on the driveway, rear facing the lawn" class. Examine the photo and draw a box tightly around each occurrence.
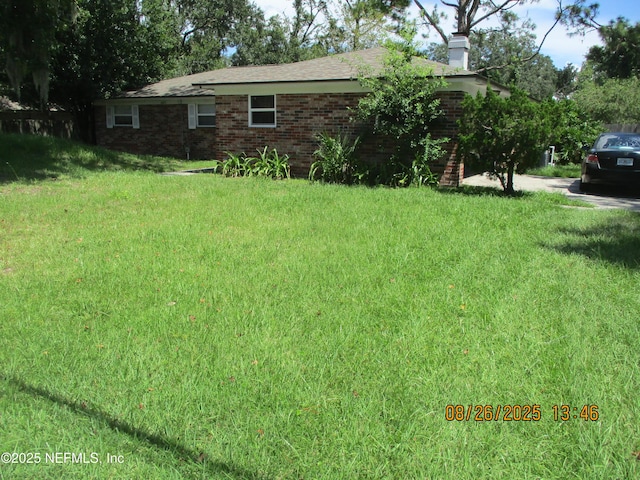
[580,133,640,191]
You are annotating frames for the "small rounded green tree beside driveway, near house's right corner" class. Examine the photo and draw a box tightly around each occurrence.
[459,87,553,195]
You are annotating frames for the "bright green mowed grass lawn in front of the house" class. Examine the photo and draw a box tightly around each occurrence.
[0,137,640,479]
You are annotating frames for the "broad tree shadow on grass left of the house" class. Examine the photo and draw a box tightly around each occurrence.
[0,134,179,184]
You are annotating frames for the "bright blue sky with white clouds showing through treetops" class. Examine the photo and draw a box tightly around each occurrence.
[253,0,640,68]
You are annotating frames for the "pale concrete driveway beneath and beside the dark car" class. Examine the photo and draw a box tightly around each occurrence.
[462,175,640,212]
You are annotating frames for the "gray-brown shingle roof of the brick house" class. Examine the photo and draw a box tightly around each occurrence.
[114,47,472,98]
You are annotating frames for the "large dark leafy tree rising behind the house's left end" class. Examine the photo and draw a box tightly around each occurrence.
[51,0,178,141]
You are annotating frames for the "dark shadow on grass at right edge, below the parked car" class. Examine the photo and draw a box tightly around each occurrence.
[544,213,640,269]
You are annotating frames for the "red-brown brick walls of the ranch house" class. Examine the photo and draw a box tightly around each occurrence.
[96,92,464,185]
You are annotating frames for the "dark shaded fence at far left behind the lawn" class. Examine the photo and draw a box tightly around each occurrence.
[0,110,78,138]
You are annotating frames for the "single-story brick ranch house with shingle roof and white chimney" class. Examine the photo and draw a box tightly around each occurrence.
[94,38,504,185]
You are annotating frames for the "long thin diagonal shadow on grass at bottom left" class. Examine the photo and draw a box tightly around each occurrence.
[0,375,268,480]
